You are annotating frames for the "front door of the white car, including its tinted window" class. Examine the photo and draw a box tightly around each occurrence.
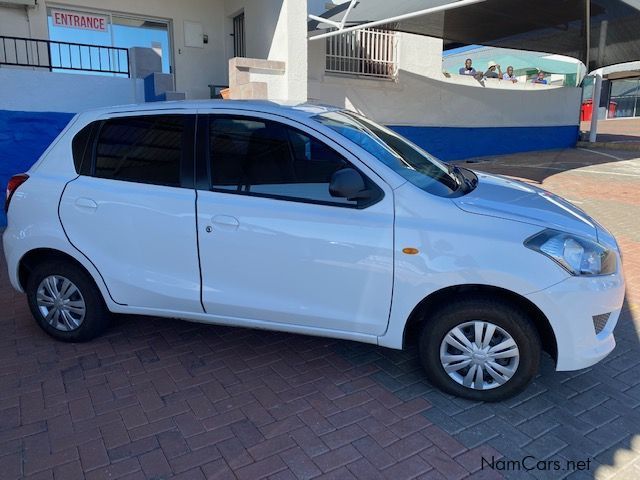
[197,113,394,336]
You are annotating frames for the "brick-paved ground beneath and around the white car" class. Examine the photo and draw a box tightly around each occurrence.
[0,150,640,480]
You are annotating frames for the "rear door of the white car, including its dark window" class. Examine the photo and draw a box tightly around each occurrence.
[59,110,202,313]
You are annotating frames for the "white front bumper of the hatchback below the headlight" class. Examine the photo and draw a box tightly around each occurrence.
[527,266,625,371]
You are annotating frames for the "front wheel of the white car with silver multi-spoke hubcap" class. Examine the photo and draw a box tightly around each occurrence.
[420,298,541,401]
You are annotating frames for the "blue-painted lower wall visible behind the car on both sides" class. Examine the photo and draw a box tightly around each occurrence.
[0,110,578,226]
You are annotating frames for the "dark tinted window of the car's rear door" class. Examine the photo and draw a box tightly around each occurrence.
[95,115,185,187]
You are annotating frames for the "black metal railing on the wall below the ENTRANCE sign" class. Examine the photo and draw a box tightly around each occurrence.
[0,35,130,77]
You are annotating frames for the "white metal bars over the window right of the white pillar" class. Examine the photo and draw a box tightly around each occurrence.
[325,28,398,78]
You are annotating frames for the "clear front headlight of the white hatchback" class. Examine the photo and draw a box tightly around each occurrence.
[524,230,616,275]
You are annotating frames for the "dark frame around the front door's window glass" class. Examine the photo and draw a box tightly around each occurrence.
[195,111,385,210]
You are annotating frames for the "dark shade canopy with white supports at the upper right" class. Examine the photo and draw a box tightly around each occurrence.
[309,0,640,70]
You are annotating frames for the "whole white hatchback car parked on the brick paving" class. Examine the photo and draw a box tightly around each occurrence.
[4,101,624,401]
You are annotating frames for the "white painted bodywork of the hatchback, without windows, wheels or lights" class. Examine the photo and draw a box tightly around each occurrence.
[3,101,624,376]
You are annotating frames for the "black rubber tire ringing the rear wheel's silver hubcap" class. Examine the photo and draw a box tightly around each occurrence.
[25,260,111,342]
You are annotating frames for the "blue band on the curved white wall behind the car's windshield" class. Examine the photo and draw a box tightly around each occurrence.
[390,125,579,161]
